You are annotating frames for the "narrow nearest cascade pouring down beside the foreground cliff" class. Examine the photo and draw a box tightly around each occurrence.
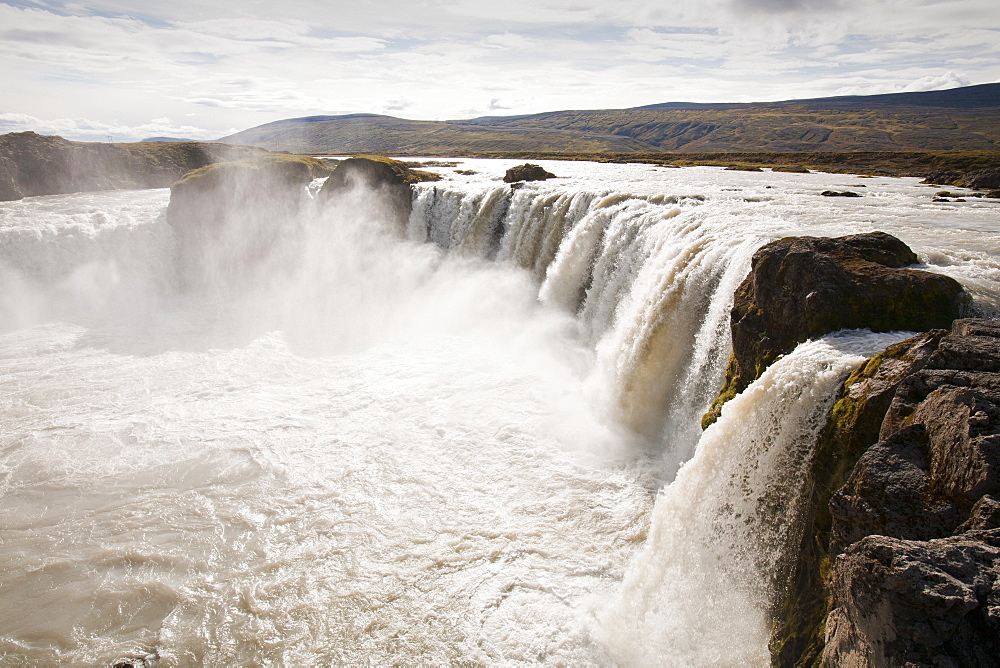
[605,331,909,666]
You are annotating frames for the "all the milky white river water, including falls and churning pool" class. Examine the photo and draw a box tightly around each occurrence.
[0,160,1000,665]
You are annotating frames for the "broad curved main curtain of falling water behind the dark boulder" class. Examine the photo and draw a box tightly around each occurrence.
[409,184,758,464]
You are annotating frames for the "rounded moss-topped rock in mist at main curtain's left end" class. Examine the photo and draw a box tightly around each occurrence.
[320,156,441,232]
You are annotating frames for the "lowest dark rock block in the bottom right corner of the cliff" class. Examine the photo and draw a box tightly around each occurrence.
[823,530,1000,667]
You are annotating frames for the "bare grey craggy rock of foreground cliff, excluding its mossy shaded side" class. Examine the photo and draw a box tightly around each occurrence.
[823,320,1000,666]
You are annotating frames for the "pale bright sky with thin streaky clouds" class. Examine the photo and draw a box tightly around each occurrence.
[0,0,1000,141]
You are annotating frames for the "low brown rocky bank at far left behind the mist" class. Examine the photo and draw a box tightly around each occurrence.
[0,132,266,201]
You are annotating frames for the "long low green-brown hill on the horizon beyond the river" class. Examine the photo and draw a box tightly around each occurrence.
[219,84,1000,155]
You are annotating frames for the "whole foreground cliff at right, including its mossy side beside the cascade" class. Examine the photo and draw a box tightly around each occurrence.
[772,320,1000,666]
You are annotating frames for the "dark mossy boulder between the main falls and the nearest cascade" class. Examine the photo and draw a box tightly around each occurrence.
[703,232,969,426]
